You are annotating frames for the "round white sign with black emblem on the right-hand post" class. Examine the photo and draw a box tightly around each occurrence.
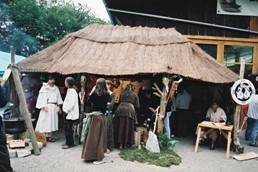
[231,79,255,105]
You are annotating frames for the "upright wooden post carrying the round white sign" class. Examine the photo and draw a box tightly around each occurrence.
[234,60,245,146]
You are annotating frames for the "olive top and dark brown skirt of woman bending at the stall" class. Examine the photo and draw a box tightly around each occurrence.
[113,91,140,147]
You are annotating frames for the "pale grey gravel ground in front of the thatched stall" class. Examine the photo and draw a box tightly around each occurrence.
[1,107,258,172]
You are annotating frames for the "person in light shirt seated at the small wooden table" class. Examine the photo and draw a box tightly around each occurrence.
[206,101,227,150]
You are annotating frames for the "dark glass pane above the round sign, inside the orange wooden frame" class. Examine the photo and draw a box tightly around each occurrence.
[224,45,253,74]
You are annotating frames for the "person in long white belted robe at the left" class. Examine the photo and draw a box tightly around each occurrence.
[35,76,63,142]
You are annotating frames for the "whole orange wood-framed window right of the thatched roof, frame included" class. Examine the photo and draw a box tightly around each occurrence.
[186,35,258,75]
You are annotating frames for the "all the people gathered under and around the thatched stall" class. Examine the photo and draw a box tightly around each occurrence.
[0,76,258,171]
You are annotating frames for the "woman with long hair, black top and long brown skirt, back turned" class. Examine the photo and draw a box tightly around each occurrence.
[81,78,110,164]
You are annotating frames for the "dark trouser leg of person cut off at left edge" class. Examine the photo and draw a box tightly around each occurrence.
[0,124,13,172]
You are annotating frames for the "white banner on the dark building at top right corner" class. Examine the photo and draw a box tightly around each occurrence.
[217,0,258,16]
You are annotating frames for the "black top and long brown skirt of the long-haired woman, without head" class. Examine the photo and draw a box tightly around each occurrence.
[81,92,110,161]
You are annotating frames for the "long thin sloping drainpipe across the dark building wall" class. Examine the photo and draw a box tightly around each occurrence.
[106,8,258,35]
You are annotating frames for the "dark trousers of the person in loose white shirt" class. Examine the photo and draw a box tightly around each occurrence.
[64,115,74,146]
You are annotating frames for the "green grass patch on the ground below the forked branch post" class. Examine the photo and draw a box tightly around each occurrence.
[119,148,181,167]
